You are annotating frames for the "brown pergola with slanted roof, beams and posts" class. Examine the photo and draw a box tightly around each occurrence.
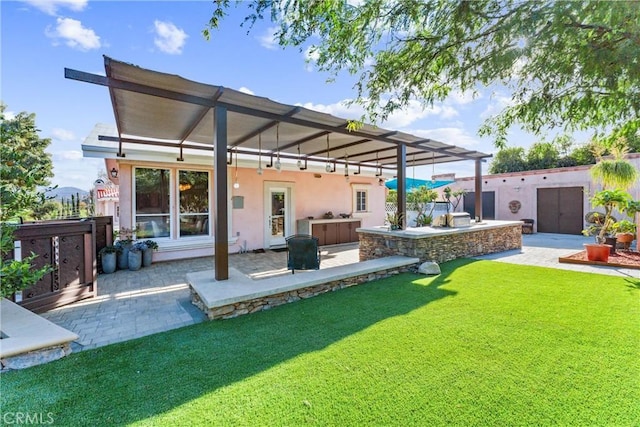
[65,56,491,280]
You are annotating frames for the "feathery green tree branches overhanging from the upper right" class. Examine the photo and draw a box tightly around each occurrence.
[208,0,640,148]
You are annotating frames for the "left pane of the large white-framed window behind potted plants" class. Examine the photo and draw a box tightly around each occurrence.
[135,168,171,238]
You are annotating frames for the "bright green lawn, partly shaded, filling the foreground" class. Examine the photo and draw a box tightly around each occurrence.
[0,260,640,426]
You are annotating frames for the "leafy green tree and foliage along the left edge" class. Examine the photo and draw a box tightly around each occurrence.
[0,104,53,297]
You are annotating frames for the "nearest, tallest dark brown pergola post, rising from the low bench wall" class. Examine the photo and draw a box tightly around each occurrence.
[213,106,229,280]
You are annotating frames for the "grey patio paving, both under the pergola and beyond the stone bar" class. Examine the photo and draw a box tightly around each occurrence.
[42,233,640,351]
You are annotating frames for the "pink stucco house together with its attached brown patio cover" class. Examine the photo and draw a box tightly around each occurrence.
[75,57,490,280]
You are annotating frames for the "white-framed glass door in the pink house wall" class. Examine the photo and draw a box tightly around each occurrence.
[265,185,293,247]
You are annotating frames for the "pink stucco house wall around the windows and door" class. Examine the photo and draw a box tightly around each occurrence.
[118,160,385,261]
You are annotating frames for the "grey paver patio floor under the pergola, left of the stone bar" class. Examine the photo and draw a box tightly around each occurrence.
[41,244,358,351]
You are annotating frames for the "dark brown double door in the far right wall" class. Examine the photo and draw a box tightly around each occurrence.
[537,187,584,234]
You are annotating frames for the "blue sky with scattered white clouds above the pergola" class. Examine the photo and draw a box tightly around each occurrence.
[0,0,539,190]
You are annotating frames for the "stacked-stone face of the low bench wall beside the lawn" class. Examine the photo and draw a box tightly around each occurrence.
[191,264,417,320]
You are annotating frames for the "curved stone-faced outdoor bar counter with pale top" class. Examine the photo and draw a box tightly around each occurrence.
[356,220,522,263]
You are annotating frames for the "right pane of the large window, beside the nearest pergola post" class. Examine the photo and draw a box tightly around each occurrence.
[178,171,209,237]
